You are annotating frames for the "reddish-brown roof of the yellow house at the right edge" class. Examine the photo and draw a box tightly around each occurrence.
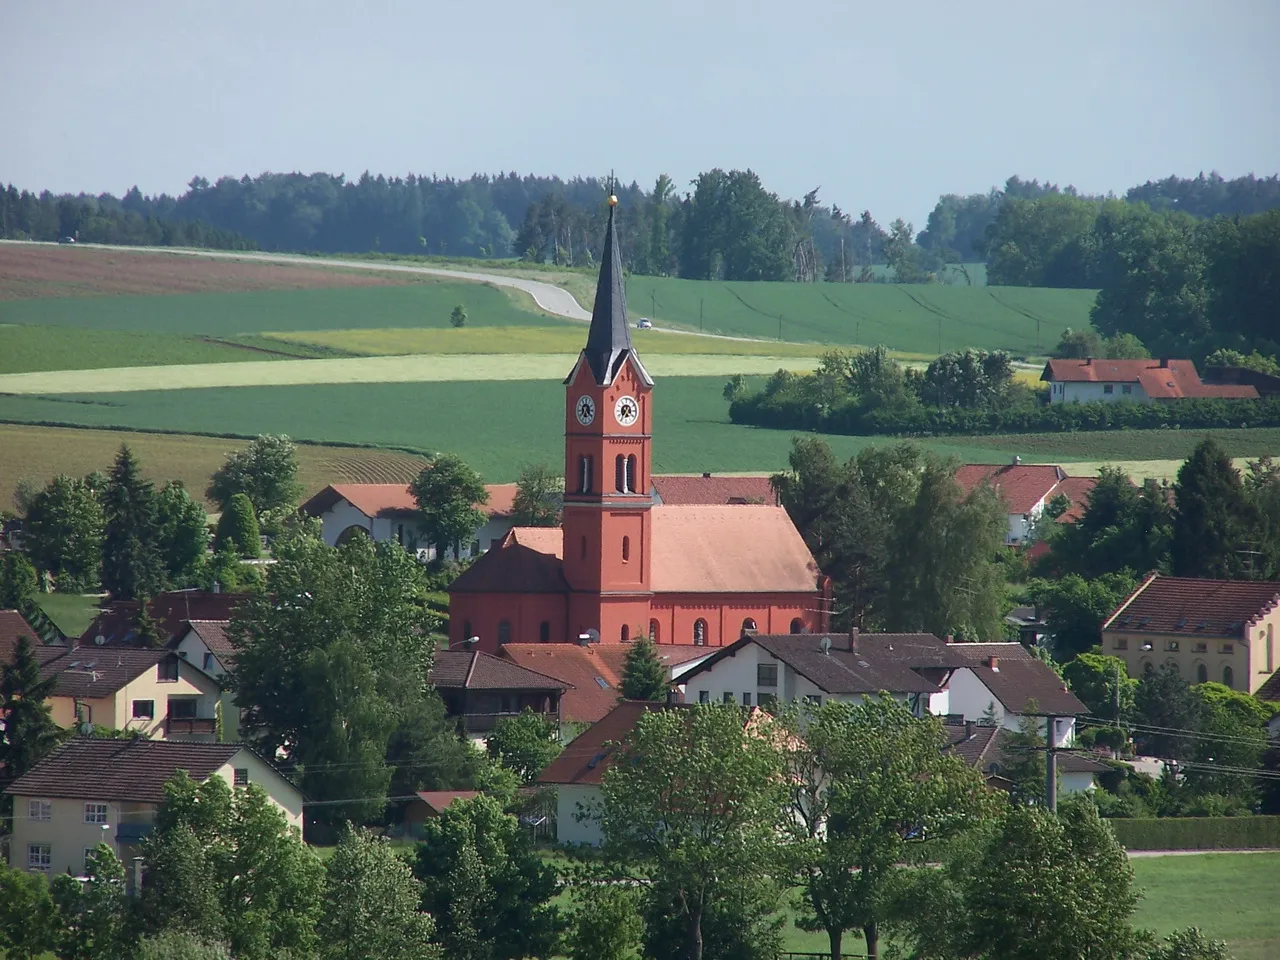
[1102,573,1280,637]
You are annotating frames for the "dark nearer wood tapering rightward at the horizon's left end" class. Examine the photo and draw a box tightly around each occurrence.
[0,184,257,250]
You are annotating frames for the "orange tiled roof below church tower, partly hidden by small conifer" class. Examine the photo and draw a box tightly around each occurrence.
[498,644,712,723]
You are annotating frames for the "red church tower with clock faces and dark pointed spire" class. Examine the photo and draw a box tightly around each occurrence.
[563,196,653,643]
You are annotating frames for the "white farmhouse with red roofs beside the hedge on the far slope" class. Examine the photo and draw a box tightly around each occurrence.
[1041,357,1258,403]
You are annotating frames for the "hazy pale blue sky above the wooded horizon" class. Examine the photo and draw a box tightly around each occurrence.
[10,0,1280,229]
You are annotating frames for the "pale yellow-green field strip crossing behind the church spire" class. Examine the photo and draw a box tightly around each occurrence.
[0,353,818,394]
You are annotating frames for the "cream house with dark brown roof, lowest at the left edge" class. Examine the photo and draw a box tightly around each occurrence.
[5,737,303,882]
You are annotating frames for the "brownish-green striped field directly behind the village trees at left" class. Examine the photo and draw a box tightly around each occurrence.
[0,424,422,512]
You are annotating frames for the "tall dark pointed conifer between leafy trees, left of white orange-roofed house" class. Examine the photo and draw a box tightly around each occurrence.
[102,445,164,600]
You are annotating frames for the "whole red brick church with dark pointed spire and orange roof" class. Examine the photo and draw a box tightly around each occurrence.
[449,196,831,653]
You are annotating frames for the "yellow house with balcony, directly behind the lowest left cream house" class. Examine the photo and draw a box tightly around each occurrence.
[41,646,221,740]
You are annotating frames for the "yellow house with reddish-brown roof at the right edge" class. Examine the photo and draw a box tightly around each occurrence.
[1102,573,1280,694]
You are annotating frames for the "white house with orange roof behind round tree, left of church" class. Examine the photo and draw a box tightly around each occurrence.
[300,484,516,559]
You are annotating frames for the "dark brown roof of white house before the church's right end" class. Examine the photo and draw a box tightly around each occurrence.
[681,634,965,694]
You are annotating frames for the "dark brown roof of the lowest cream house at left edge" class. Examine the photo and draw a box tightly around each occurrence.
[5,737,246,804]
